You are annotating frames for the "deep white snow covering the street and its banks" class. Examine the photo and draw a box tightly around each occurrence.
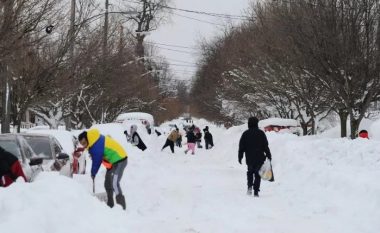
[0,121,380,233]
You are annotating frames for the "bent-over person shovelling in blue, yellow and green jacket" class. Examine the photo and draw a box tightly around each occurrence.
[78,129,128,210]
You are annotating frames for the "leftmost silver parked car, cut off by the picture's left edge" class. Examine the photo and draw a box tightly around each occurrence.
[0,134,43,182]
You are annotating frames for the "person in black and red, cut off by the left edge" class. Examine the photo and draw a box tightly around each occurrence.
[0,146,27,187]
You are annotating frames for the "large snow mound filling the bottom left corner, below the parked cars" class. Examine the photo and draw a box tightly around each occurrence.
[0,173,125,233]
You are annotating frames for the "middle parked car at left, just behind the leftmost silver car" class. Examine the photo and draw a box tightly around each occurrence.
[20,133,73,177]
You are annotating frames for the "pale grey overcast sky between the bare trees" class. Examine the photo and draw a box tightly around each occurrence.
[147,0,250,83]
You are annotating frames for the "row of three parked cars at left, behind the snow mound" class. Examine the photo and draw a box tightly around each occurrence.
[0,130,86,182]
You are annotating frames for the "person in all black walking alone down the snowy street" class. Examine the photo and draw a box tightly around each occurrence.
[239,117,272,197]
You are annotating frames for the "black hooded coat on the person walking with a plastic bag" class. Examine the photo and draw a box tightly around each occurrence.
[239,128,272,167]
